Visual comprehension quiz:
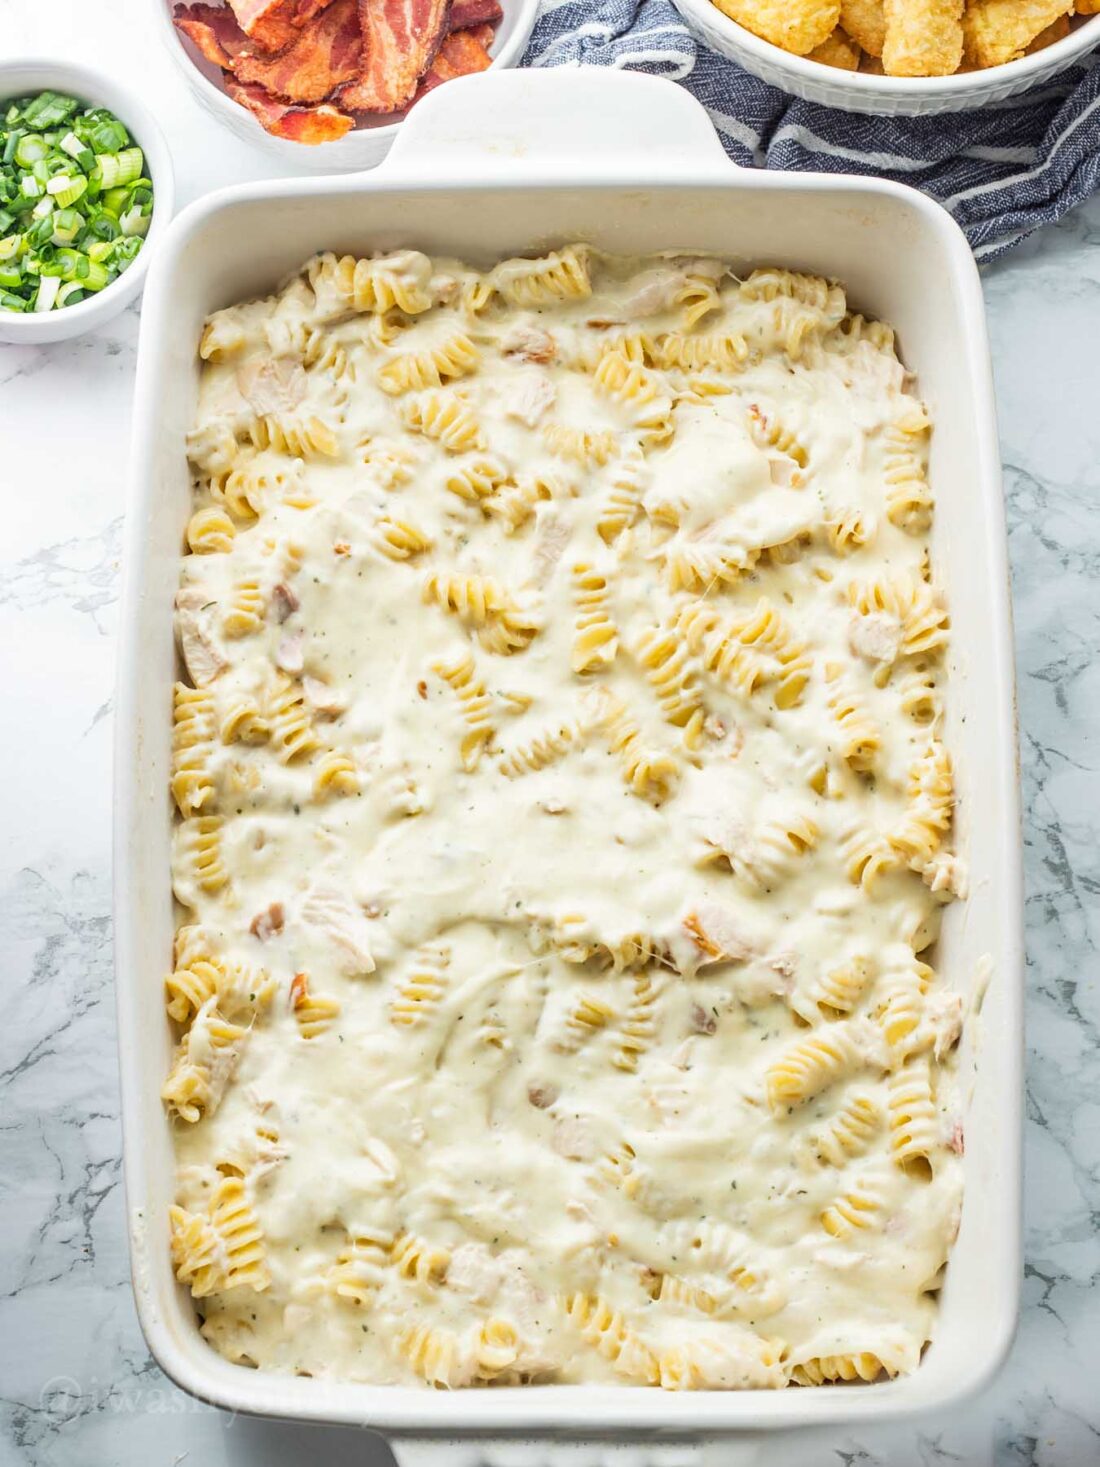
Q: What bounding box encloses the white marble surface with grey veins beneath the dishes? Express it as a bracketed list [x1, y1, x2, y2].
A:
[0, 0, 1100, 1467]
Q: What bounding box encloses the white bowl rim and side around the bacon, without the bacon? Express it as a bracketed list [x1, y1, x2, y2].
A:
[158, 0, 538, 173]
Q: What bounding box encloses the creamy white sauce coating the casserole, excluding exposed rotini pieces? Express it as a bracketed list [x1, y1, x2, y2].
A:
[165, 254, 961, 1388]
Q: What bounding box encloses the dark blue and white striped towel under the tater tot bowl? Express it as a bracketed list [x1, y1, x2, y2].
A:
[524, 0, 1100, 261]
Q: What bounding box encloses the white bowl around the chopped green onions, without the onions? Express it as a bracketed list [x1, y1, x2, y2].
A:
[0, 60, 173, 346]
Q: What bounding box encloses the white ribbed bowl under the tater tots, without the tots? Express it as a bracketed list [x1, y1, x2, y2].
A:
[672, 0, 1100, 117]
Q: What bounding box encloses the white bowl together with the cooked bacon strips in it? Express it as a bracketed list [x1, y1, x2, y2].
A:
[154, 0, 538, 173]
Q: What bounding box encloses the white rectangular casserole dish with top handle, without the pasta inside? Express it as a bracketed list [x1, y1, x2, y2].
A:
[114, 69, 1022, 1460]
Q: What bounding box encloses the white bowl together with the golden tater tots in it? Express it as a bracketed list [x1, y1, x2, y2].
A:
[673, 0, 1100, 116]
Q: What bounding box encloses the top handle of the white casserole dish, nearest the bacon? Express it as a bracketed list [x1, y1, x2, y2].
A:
[380, 66, 736, 182]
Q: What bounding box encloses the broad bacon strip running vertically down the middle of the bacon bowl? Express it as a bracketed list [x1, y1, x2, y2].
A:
[340, 0, 450, 111]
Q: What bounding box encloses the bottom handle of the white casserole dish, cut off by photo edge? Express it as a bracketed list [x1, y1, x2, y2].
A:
[387, 1432, 763, 1467]
